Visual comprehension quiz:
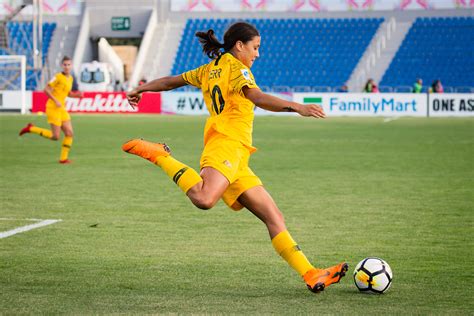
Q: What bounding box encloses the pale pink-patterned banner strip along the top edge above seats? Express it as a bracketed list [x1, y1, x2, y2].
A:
[171, 0, 474, 12]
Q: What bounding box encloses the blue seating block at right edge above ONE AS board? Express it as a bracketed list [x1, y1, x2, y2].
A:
[381, 17, 474, 92]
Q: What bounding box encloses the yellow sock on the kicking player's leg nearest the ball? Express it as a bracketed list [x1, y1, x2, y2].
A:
[272, 230, 314, 276]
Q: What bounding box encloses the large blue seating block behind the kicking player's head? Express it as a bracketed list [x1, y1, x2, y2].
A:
[172, 19, 383, 92]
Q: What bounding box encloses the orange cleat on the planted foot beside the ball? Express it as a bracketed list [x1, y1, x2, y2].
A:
[303, 262, 349, 293]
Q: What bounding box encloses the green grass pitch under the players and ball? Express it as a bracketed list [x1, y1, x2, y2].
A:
[0, 115, 474, 315]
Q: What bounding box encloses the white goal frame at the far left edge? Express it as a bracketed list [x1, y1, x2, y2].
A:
[0, 55, 27, 114]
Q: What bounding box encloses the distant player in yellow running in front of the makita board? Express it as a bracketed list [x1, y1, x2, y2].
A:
[20, 56, 82, 164]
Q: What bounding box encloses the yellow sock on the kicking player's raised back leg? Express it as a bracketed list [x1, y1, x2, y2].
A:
[156, 156, 202, 193]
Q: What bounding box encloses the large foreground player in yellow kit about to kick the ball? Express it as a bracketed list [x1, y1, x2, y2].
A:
[122, 22, 348, 293]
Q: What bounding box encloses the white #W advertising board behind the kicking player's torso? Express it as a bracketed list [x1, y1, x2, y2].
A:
[161, 92, 296, 115]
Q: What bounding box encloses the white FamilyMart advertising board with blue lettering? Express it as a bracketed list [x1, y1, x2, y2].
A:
[293, 93, 428, 117]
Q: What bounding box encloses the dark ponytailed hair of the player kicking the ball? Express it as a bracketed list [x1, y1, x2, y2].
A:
[196, 22, 260, 59]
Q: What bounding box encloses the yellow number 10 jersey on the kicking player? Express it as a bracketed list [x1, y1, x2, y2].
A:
[181, 53, 258, 152]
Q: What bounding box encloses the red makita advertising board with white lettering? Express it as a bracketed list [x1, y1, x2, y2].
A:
[32, 92, 161, 114]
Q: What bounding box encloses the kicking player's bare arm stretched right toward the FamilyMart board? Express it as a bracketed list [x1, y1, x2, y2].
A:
[242, 87, 326, 118]
